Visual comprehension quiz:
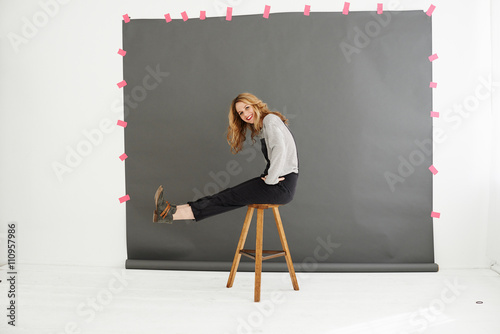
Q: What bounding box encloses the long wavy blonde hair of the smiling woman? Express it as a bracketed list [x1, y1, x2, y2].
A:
[227, 93, 288, 154]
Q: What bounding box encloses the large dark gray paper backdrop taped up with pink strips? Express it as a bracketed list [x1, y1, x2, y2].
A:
[123, 11, 437, 271]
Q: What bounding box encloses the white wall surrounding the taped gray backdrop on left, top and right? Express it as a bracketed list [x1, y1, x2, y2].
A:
[0, 0, 500, 268]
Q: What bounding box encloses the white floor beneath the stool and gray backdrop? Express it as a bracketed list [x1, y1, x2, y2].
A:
[0, 265, 500, 334]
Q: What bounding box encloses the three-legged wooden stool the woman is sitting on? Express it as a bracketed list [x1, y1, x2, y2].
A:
[227, 204, 299, 302]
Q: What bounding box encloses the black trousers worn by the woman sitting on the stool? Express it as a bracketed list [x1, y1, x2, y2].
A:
[188, 173, 299, 221]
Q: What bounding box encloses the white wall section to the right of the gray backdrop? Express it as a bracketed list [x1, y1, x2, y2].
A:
[433, 1, 492, 267]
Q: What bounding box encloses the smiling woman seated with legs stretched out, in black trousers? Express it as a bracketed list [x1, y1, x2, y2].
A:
[153, 93, 299, 224]
